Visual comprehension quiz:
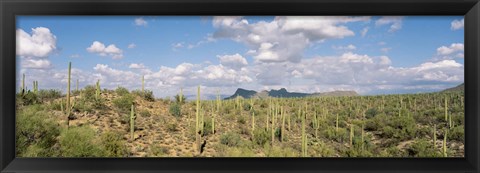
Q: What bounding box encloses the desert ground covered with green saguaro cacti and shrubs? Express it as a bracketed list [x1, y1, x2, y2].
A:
[16, 64, 465, 157]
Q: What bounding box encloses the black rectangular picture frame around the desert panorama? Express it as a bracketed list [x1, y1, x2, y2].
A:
[0, 0, 480, 173]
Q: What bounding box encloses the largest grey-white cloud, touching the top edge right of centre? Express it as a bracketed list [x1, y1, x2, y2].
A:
[212, 16, 370, 63]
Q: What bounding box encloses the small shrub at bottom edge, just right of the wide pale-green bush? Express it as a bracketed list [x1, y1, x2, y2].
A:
[101, 132, 127, 157]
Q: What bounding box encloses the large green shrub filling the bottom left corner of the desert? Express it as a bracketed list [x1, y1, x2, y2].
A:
[15, 105, 60, 157]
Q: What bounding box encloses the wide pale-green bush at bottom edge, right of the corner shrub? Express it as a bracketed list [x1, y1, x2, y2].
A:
[59, 126, 104, 157]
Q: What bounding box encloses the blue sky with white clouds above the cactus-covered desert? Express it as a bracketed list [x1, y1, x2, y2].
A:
[16, 16, 464, 97]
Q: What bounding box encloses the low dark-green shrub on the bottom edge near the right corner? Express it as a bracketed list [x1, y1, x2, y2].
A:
[406, 139, 442, 157]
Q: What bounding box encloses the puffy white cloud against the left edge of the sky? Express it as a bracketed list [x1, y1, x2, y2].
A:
[16, 27, 57, 58]
